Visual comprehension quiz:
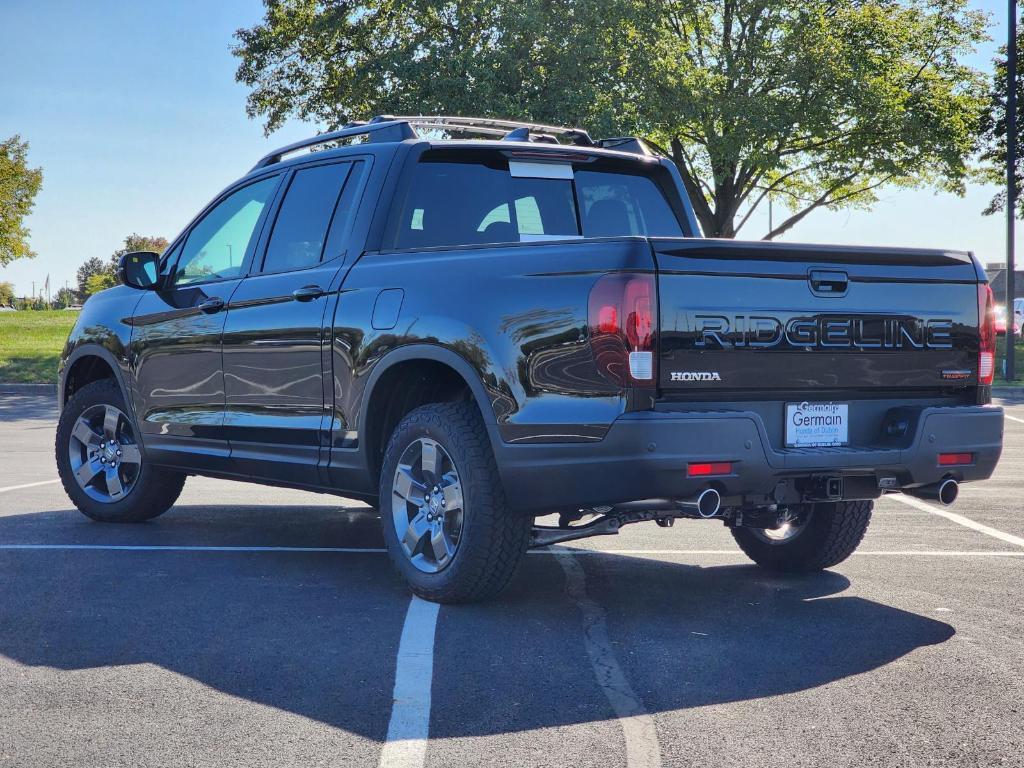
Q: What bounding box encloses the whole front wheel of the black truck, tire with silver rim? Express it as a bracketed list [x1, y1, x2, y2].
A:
[56, 379, 185, 522]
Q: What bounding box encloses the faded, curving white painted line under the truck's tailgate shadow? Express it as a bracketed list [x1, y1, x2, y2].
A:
[558, 552, 662, 768]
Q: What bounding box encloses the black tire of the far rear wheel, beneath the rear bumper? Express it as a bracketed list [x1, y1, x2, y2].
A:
[731, 501, 874, 572]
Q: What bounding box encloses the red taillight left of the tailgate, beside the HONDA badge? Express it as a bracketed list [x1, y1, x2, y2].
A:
[588, 272, 657, 387]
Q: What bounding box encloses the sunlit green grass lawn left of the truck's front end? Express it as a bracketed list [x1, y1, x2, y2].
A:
[0, 309, 78, 384]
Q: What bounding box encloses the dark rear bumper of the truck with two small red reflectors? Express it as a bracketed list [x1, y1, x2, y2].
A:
[496, 406, 1002, 513]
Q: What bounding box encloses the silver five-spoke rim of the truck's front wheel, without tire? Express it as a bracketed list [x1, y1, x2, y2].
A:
[68, 404, 142, 504]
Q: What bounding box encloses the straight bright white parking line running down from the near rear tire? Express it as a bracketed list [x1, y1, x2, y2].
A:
[378, 597, 440, 768]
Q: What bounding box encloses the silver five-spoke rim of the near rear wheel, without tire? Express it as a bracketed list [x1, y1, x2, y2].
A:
[391, 437, 465, 573]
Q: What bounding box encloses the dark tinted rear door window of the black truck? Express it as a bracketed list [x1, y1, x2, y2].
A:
[262, 163, 351, 272]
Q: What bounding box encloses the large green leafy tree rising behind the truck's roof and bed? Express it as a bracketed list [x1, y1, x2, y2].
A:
[234, 0, 985, 237]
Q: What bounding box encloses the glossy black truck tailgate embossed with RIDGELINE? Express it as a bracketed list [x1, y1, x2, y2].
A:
[651, 239, 979, 399]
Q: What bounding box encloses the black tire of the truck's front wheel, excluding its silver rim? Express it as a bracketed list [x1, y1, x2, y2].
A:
[55, 379, 185, 522]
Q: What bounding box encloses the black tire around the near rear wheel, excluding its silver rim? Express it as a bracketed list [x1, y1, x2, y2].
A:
[379, 402, 532, 603]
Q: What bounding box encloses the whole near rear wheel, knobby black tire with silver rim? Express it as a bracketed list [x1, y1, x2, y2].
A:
[380, 402, 532, 603]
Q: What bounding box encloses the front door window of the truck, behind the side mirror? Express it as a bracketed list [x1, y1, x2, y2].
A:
[174, 176, 278, 285]
